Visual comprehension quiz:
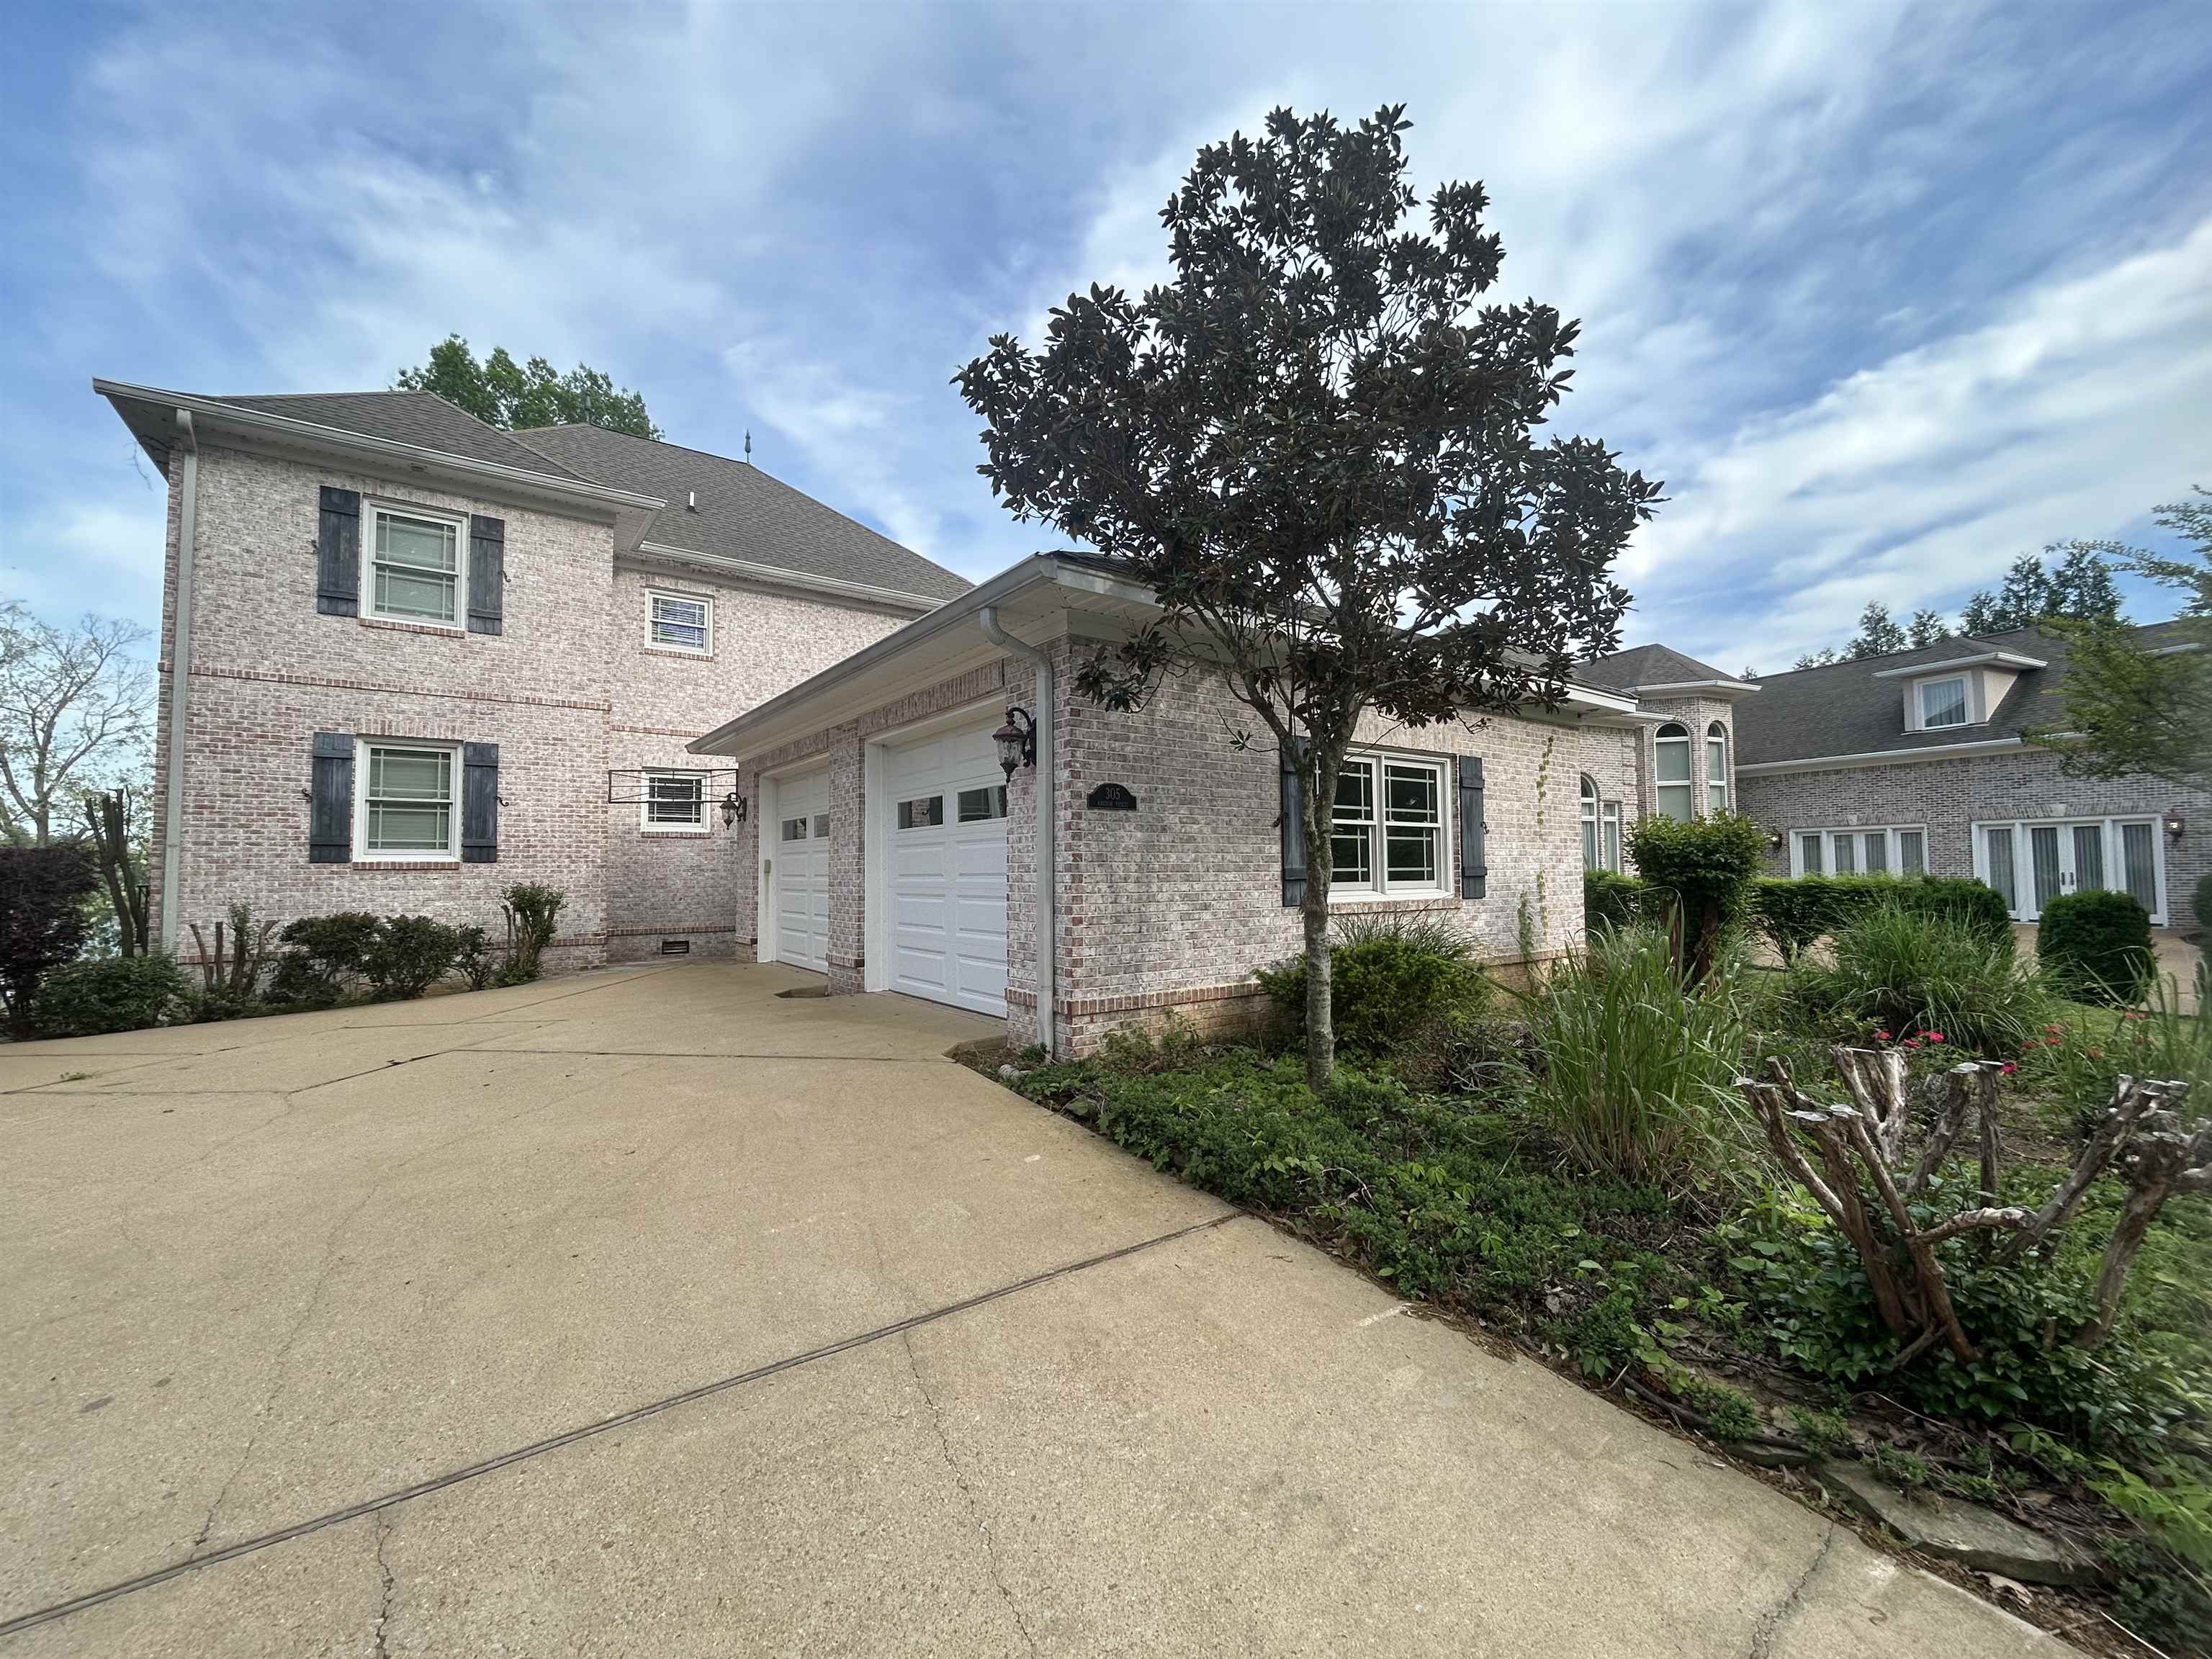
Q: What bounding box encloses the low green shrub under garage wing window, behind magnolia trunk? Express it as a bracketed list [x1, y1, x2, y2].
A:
[1259, 914, 1488, 1059]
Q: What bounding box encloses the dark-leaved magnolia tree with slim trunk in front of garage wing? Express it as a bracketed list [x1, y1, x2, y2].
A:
[958, 109, 1659, 1086]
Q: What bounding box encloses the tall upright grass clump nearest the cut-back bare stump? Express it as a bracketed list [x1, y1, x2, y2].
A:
[1515, 927, 1745, 1184]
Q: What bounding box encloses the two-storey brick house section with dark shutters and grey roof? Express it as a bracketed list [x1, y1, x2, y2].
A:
[95, 380, 969, 966]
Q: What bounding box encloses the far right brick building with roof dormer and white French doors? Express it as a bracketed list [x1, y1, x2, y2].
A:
[1737, 626, 2212, 927]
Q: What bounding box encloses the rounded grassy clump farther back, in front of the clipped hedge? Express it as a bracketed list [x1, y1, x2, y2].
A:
[1789, 904, 2051, 1057]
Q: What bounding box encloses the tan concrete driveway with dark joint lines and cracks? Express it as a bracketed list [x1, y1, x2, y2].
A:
[0, 964, 2064, 1659]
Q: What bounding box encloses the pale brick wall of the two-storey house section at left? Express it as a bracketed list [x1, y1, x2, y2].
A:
[150, 444, 904, 969]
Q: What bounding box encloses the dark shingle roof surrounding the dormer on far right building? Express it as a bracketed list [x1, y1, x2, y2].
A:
[1737, 621, 2172, 765]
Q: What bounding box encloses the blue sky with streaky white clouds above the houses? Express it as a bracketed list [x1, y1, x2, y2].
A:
[0, 0, 2212, 670]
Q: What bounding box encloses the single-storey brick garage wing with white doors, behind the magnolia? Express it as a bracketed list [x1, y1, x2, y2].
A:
[693, 553, 1750, 1053]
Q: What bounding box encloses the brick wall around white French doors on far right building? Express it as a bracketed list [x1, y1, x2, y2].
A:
[1739, 750, 2212, 927]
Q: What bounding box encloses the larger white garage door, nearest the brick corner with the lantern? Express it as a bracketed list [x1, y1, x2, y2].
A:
[876, 726, 1007, 1017]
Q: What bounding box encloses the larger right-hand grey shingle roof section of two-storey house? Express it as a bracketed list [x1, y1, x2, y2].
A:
[516, 427, 974, 600]
